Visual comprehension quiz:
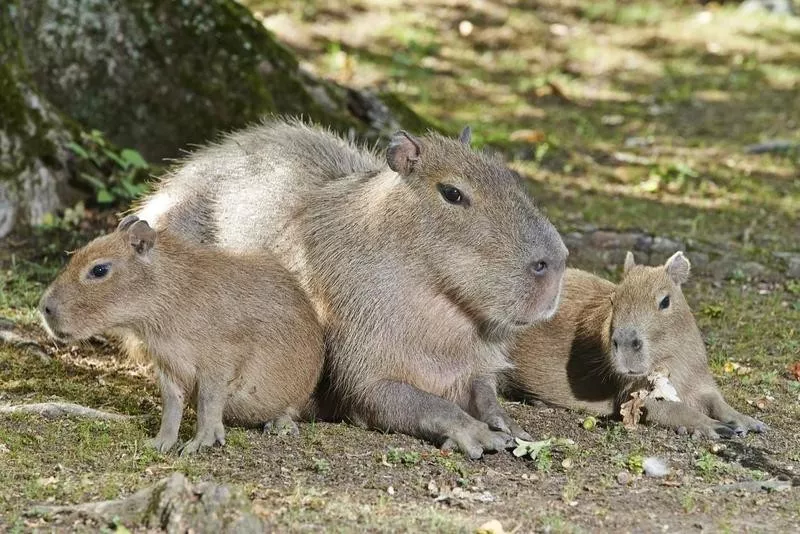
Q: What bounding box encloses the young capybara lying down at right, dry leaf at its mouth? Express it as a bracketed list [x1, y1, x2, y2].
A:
[506, 252, 766, 438]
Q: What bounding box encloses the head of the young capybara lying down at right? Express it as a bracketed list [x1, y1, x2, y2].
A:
[610, 252, 697, 378]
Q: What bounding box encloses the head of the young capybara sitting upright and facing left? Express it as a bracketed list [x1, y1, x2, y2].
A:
[39, 215, 156, 339]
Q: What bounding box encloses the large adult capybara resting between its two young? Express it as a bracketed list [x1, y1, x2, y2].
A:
[133, 120, 567, 458]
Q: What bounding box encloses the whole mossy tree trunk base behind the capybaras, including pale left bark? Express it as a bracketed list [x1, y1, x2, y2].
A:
[0, 0, 430, 236]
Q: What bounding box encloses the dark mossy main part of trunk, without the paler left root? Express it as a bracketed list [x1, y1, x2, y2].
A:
[11, 0, 434, 161]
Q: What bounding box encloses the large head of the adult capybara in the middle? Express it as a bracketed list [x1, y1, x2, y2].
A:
[387, 127, 567, 328]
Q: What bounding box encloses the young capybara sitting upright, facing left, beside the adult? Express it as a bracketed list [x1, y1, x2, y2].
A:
[39, 215, 324, 454]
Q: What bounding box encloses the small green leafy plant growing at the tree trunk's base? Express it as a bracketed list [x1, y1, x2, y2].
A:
[67, 130, 150, 204]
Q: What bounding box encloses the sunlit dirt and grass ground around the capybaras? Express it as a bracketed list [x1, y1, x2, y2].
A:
[0, 0, 800, 532]
